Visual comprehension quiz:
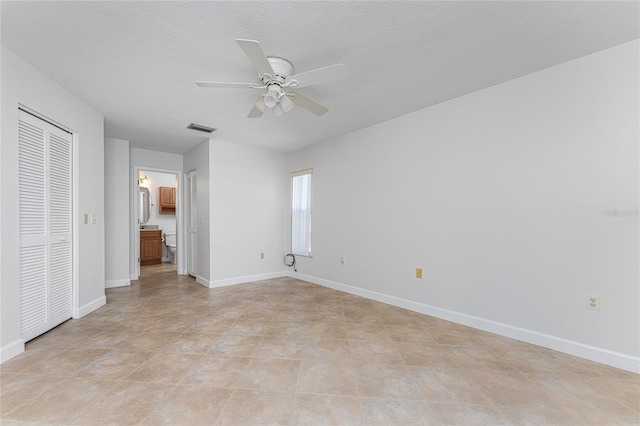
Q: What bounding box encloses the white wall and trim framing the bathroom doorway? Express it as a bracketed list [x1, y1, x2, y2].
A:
[129, 148, 184, 279]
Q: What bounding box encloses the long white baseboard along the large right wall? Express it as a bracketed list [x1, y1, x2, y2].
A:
[286, 271, 640, 374]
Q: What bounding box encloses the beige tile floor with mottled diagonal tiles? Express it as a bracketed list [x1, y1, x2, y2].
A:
[0, 265, 640, 425]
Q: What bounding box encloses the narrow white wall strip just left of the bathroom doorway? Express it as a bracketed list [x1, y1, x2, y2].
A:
[104, 138, 130, 288]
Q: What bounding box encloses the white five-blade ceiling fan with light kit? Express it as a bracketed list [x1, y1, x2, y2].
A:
[196, 39, 347, 118]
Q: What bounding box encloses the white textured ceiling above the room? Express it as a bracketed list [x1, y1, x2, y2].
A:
[1, 1, 639, 153]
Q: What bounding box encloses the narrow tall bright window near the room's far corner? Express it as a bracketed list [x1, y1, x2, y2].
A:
[291, 169, 313, 257]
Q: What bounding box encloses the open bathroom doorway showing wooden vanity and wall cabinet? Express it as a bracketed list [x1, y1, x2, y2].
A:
[132, 166, 183, 279]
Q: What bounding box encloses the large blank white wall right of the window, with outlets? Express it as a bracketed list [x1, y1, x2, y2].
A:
[288, 41, 640, 371]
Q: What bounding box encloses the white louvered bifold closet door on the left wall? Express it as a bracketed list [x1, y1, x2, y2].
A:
[18, 111, 72, 340]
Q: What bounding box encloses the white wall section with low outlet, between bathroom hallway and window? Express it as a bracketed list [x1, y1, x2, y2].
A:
[209, 140, 289, 286]
